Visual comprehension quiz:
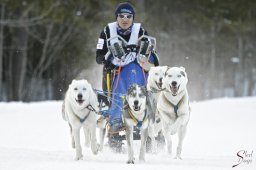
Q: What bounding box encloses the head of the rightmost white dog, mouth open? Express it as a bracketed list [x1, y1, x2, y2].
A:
[163, 67, 188, 96]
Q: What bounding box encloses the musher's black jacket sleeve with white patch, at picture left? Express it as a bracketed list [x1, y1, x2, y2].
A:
[96, 27, 108, 64]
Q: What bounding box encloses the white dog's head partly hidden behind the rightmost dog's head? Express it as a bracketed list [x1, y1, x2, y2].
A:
[147, 66, 167, 91]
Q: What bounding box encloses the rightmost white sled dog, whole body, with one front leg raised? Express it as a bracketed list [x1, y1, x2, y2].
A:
[157, 67, 190, 159]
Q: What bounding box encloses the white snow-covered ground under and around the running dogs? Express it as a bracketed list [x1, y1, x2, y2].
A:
[0, 97, 256, 170]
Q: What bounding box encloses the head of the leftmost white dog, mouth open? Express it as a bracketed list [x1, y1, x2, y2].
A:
[68, 79, 98, 110]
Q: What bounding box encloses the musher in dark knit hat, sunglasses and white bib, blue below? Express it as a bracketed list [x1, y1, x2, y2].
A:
[96, 2, 159, 149]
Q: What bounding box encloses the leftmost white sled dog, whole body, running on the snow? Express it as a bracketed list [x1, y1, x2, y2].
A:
[62, 79, 99, 160]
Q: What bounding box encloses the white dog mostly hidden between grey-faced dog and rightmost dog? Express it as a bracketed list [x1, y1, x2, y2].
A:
[147, 66, 168, 153]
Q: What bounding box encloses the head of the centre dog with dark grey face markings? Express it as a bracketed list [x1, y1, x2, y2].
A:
[124, 84, 147, 114]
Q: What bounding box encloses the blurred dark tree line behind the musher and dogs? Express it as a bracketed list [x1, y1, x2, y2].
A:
[0, 0, 256, 101]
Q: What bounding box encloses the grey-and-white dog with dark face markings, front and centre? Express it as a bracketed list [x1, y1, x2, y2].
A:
[122, 84, 149, 164]
